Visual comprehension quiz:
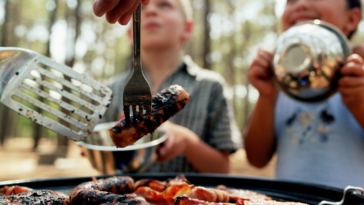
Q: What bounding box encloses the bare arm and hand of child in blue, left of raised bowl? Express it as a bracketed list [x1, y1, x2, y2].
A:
[244, 50, 278, 167]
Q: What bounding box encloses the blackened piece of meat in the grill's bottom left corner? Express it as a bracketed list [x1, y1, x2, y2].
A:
[0, 190, 71, 205]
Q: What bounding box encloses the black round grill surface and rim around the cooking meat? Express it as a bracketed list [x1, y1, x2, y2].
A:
[0, 173, 364, 205]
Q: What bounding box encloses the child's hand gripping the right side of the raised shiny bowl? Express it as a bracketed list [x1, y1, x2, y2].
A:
[337, 54, 364, 109]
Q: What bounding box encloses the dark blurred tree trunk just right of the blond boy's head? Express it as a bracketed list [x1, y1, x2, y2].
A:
[202, 0, 211, 70]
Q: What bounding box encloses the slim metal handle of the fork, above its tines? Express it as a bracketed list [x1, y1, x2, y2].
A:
[133, 4, 142, 72]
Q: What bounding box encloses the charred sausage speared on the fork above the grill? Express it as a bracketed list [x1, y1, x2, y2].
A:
[109, 85, 189, 147]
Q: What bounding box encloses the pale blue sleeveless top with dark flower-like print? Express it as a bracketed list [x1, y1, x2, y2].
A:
[274, 93, 364, 188]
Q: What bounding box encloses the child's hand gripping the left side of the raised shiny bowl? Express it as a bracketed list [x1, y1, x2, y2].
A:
[248, 49, 278, 97]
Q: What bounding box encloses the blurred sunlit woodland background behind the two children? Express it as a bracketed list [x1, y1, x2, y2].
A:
[0, 0, 364, 181]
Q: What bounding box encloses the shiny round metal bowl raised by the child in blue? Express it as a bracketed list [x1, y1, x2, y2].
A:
[273, 20, 351, 102]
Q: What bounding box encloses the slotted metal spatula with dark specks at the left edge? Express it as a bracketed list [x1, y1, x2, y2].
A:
[0, 47, 112, 141]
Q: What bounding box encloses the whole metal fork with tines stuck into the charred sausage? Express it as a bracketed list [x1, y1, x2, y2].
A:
[123, 5, 152, 122]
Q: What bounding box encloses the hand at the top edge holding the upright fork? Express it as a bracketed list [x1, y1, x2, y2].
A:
[94, 0, 150, 25]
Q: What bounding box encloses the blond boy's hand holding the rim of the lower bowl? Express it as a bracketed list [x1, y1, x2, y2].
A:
[157, 121, 199, 162]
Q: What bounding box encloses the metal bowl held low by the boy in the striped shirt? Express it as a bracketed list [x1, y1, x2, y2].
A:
[77, 122, 167, 175]
